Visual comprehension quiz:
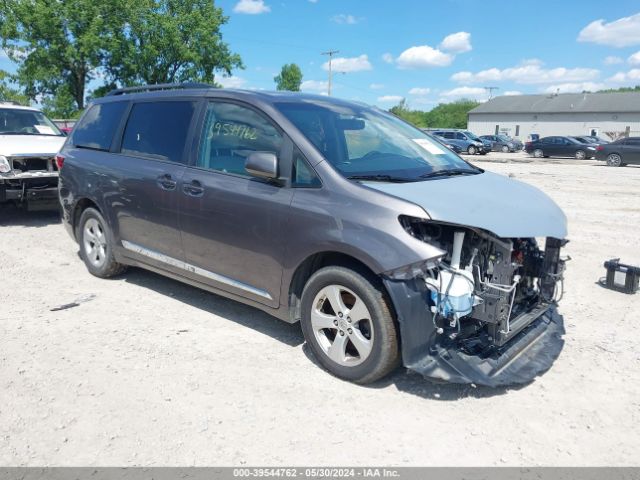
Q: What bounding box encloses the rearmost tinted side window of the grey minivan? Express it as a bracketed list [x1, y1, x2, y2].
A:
[71, 102, 128, 151]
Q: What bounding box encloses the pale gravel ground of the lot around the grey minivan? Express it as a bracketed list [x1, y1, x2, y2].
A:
[0, 154, 640, 466]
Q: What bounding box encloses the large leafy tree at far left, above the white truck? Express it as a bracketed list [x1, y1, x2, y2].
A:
[0, 0, 127, 109]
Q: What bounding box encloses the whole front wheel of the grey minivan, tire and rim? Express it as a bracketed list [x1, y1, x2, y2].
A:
[301, 267, 400, 384]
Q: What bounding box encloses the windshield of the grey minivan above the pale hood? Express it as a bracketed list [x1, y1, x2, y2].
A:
[276, 100, 482, 182]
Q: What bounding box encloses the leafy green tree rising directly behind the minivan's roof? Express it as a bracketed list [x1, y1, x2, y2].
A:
[105, 0, 243, 86]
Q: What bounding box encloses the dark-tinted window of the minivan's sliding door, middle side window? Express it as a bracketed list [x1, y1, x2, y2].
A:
[121, 101, 195, 162]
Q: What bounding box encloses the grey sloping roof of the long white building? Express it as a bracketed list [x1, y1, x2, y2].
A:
[469, 92, 640, 115]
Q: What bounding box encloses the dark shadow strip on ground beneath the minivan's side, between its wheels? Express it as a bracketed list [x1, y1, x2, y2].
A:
[121, 268, 304, 347]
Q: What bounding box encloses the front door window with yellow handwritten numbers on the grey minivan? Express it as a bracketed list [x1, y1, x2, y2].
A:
[196, 102, 282, 177]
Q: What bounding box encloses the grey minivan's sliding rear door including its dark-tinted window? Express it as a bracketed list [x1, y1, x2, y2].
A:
[111, 99, 197, 272]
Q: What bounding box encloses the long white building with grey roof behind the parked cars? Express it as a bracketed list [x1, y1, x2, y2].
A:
[468, 92, 640, 141]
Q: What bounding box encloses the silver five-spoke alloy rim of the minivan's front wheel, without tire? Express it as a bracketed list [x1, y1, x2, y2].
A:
[311, 285, 374, 367]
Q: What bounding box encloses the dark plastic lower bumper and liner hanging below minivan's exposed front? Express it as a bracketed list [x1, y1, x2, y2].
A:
[384, 279, 565, 387]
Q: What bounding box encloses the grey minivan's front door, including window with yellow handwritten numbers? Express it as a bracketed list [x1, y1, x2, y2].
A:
[178, 100, 292, 307]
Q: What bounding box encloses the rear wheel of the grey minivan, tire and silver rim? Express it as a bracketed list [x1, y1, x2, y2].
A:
[78, 207, 127, 278]
